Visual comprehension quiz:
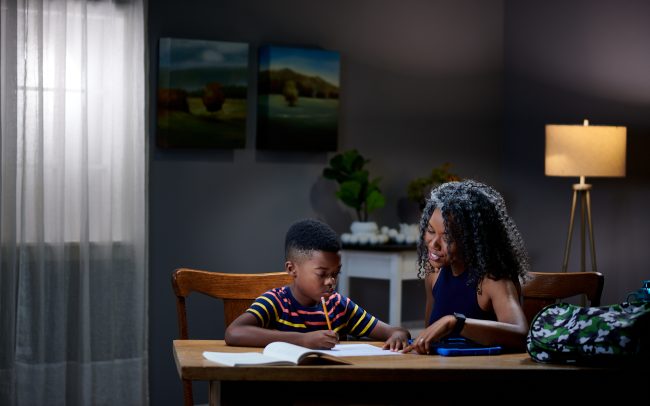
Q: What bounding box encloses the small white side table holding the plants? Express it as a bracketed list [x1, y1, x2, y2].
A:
[337, 246, 418, 326]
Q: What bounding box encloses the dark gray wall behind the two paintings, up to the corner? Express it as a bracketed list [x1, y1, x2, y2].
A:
[148, 0, 503, 405]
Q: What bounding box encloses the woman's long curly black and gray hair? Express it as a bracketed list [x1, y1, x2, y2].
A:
[417, 180, 530, 281]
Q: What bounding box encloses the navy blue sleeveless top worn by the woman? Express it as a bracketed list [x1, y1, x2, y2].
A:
[429, 267, 496, 325]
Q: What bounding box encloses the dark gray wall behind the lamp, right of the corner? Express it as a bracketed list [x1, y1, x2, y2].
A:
[503, 0, 650, 304]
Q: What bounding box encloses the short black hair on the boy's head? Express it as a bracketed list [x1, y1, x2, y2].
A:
[284, 219, 341, 259]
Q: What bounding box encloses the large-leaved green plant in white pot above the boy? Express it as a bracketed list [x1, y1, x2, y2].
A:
[323, 149, 386, 232]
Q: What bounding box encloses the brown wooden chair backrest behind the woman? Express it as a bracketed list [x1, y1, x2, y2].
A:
[521, 272, 605, 323]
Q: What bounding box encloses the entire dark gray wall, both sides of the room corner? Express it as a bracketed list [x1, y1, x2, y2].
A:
[148, 0, 650, 405]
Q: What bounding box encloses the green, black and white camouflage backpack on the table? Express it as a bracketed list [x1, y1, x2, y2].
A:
[526, 302, 650, 364]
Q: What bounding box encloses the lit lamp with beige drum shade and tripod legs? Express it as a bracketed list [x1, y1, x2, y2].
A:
[545, 120, 626, 272]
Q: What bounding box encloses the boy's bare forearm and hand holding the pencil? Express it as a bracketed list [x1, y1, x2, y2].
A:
[225, 312, 338, 349]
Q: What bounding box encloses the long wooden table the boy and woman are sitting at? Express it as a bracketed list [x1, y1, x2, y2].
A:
[173, 340, 650, 405]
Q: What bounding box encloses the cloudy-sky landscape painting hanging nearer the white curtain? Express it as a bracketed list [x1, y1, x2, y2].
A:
[156, 38, 248, 148]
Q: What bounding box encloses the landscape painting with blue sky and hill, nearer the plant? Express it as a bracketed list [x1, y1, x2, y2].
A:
[257, 46, 340, 151]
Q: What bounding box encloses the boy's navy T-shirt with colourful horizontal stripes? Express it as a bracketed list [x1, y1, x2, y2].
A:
[246, 286, 377, 337]
